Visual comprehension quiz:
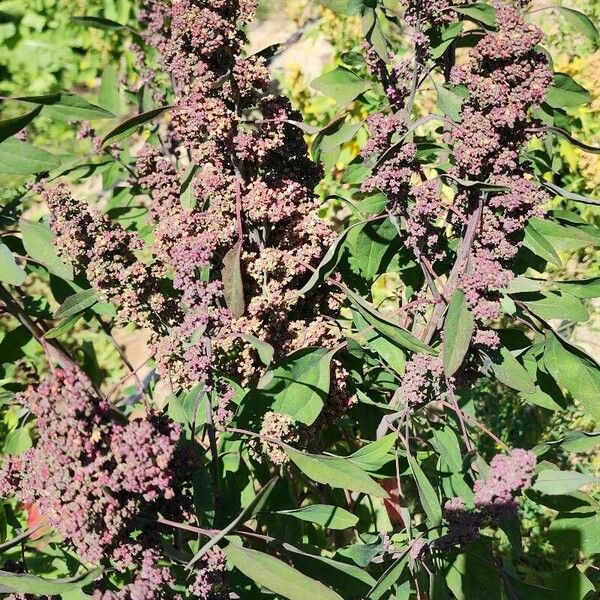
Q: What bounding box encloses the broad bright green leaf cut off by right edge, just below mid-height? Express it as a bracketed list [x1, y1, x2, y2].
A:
[544, 332, 600, 420]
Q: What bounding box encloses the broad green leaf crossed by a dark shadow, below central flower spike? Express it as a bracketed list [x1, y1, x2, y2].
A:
[259, 348, 335, 425]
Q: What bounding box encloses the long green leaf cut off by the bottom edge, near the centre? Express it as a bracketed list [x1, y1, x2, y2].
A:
[224, 544, 343, 600]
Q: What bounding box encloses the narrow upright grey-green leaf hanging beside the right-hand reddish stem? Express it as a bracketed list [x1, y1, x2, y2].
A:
[444, 290, 475, 377]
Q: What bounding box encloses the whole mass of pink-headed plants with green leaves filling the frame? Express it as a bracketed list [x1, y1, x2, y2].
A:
[0, 0, 600, 600]
